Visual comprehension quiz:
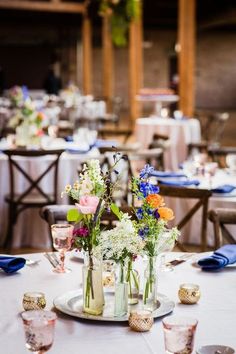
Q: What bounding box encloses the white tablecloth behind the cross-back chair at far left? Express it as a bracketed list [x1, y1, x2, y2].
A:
[0, 149, 98, 248]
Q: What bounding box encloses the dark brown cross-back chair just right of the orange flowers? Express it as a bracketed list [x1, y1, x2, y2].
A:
[159, 185, 212, 251]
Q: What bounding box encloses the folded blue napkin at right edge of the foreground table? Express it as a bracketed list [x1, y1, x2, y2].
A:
[198, 245, 236, 270]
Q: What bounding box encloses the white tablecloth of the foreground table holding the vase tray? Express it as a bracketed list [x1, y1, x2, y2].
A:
[0, 254, 236, 354]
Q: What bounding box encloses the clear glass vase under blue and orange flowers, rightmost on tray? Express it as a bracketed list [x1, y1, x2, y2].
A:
[143, 257, 157, 311]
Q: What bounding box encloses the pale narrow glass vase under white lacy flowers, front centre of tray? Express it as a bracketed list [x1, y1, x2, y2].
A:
[114, 263, 128, 317]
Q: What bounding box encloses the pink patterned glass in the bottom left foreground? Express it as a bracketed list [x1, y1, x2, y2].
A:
[21, 310, 57, 354]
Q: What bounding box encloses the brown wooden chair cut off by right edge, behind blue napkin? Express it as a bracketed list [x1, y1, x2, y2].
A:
[208, 208, 236, 249]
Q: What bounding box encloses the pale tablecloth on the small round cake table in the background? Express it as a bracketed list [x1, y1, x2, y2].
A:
[135, 118, 201, 170]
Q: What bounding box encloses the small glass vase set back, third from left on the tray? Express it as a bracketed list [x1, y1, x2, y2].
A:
[126, 259, 139, 305]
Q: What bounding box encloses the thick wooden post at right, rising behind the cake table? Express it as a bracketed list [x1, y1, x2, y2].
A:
[178, 0, 196, 117]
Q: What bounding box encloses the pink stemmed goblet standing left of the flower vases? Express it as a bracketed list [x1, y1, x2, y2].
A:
[51, 224, 74, 273]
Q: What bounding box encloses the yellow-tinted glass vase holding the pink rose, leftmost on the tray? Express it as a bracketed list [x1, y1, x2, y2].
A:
[83, 256, 104, 316]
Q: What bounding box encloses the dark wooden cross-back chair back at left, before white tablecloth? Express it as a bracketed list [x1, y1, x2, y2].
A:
[3, 149, 64, 205]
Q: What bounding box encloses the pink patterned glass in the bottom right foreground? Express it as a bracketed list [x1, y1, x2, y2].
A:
[162, 316, 198, 354]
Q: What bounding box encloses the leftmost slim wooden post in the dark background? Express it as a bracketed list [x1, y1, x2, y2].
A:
[82, 15, 92, 95]
